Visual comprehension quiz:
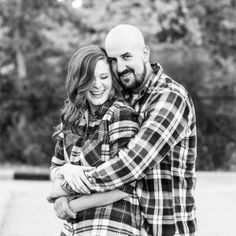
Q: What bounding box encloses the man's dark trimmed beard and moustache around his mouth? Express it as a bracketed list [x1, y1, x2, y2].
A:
[118, 64, 147, 91]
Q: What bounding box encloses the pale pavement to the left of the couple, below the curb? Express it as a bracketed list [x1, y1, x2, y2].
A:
[0, 180, 61, 236]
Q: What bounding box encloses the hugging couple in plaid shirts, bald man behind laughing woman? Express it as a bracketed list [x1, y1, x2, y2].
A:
[48, 24, 197, 236]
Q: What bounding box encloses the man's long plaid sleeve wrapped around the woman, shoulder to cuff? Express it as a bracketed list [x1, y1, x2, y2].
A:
[89, 91, 191, 192]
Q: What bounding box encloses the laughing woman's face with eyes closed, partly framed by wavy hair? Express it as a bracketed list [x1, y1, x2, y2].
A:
[86, 60, 112, 113]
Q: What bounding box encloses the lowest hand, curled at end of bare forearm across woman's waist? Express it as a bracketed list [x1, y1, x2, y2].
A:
[54, 197, 76, 220]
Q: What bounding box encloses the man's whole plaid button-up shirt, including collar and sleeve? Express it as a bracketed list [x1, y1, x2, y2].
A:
[86, 64, 196, 236]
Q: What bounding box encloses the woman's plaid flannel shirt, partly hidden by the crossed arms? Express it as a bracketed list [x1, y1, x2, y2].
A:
[51, 100, 141, 236]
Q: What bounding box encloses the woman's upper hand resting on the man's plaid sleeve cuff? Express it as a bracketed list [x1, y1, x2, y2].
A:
[60, 163, 94, 194]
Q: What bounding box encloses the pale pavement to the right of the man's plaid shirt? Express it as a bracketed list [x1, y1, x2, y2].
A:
[196, 172, 236, 236]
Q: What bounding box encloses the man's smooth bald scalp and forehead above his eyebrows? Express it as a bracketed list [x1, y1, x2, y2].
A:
[105, 24, 145, 51]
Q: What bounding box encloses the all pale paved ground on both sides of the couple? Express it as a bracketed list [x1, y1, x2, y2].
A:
[0, 172, 236, 236]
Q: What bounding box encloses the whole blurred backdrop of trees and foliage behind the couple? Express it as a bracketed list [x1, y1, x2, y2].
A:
[0, 0, 236, 171]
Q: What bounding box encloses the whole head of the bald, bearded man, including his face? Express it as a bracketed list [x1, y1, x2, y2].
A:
[102, 24, 151, 92]
